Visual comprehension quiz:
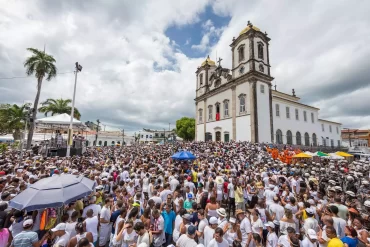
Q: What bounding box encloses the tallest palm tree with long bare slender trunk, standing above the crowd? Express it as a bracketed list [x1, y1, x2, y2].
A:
[24, 48, 57, 149]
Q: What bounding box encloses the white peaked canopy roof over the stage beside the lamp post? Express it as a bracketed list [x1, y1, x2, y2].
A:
[35, 113, 87, 129]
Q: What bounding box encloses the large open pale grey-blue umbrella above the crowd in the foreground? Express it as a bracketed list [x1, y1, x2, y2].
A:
[9, 174, 95, 211]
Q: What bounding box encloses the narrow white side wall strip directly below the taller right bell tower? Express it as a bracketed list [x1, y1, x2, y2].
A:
[256, 81, 271, 143]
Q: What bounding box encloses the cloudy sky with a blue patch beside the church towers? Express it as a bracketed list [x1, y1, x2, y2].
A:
[0, 0, 370, 132]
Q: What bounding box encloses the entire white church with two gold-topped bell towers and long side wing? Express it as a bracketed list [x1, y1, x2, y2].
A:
[195, 22, 341, 147]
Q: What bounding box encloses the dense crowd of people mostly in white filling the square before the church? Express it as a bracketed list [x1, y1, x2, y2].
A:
[0, 142, 370, 247]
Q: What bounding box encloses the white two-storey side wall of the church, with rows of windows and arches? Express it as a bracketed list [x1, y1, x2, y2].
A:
[272, 99, 320, 145]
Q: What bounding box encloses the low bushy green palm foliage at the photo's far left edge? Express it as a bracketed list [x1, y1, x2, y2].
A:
[0, 104, 30, 140]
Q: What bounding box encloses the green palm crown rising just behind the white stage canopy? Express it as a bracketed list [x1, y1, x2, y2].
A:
[39, 99, 81, 120]
